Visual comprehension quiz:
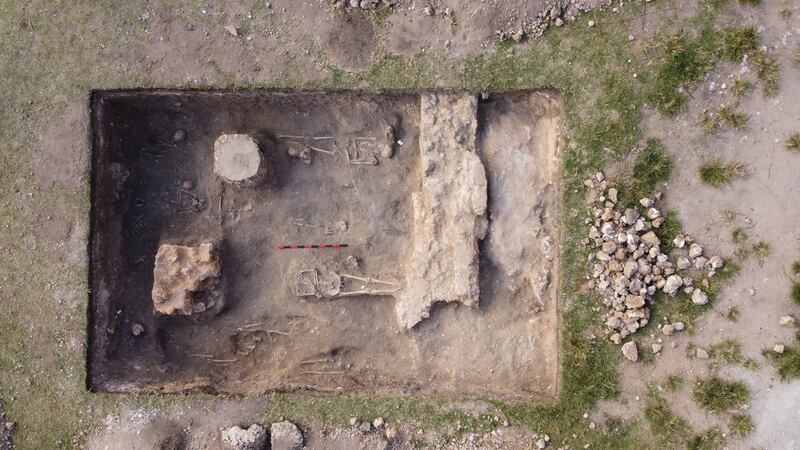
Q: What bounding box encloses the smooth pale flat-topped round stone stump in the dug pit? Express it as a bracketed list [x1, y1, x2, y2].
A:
[214, 134, 267, 185]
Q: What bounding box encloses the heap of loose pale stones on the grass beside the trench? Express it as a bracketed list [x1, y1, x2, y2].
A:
[584, 173, 723, 344]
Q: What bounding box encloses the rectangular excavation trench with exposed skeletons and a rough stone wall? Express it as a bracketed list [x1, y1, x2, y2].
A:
[87, 91, 561, 400]
